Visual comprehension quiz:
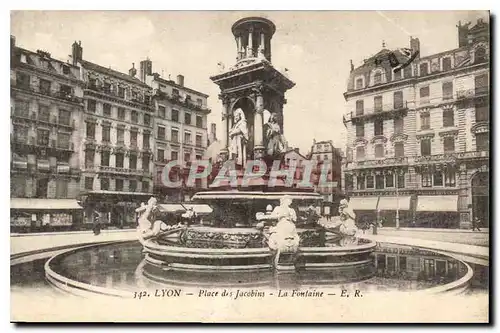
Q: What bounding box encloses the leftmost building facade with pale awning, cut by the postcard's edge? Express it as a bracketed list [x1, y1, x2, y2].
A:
[10, 36, 83, 231]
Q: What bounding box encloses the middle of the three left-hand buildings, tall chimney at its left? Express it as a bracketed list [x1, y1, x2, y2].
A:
[72, 42, 154, 227]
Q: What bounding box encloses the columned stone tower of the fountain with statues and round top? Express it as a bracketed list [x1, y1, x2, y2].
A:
[211, 17, 295, 166]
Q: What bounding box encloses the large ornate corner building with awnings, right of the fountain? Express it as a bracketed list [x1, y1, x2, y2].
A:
[343, 20, 490, 228]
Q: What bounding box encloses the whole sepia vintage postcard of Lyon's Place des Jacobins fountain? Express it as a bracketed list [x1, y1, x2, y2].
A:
[9, 11, 491, 323]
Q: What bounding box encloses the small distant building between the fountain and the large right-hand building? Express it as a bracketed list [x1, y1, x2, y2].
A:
[310, 140, 342, 215]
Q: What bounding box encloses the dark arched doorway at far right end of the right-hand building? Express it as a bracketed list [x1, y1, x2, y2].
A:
[471, 172, 490, 228]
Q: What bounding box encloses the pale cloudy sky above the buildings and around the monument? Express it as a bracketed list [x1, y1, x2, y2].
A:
[11, 11, 487, 154]
